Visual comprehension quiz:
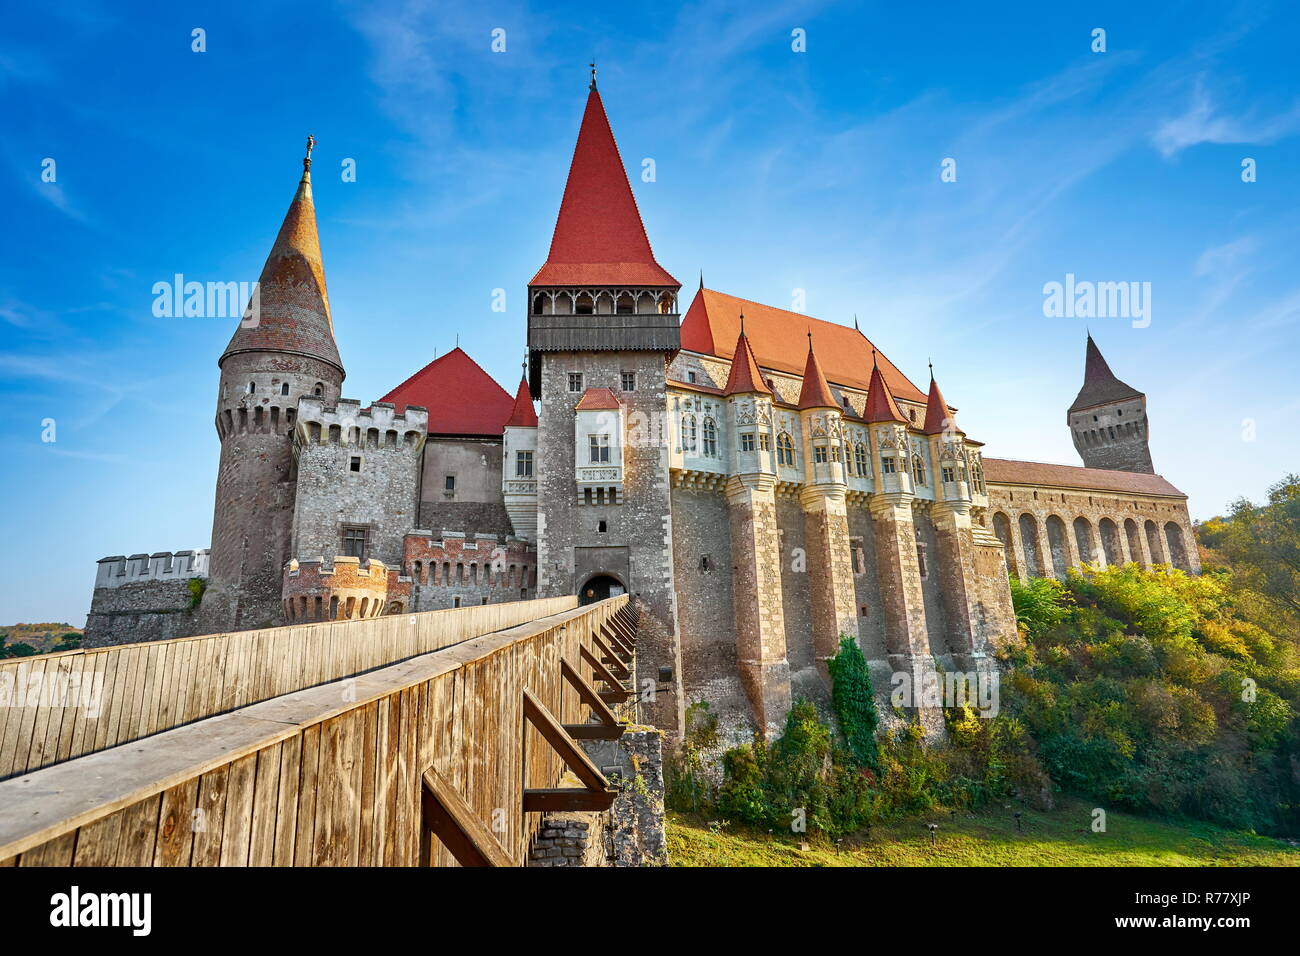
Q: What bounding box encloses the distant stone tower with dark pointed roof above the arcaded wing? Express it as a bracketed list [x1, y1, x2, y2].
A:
[1066, 334, 1156, 475]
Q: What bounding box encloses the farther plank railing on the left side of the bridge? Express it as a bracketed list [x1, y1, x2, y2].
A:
[0, 596, 577, 780]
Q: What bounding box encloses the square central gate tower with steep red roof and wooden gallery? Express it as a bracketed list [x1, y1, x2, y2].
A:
[528, 70, 684, 730]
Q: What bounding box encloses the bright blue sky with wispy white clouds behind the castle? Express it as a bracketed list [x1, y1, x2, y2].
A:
[0, 0, 1300, 626]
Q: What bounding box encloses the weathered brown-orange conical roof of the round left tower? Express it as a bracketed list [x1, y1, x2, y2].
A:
[217, 137, 343, 372]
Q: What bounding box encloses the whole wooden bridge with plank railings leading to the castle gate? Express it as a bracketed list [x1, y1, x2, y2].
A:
[0, 596, 638, 866]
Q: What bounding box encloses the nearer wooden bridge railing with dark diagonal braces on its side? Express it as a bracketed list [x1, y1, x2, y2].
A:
[0, 596, 637, 866]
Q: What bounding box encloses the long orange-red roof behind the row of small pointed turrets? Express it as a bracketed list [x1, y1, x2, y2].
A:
[681, 289, 926, 402]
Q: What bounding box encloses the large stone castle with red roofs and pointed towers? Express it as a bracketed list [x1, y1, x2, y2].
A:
[86, 75, 1199, 732]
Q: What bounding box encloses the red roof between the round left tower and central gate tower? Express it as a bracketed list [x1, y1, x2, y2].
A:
[380, 347, 515, 436]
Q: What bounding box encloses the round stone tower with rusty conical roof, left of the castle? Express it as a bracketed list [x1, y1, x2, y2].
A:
[198, 138, 345, 633]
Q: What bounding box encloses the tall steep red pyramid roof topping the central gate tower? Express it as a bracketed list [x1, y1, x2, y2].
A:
[529, 87, 680, 286]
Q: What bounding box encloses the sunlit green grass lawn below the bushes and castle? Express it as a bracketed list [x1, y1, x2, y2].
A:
[668, 799, 1300, 866]
